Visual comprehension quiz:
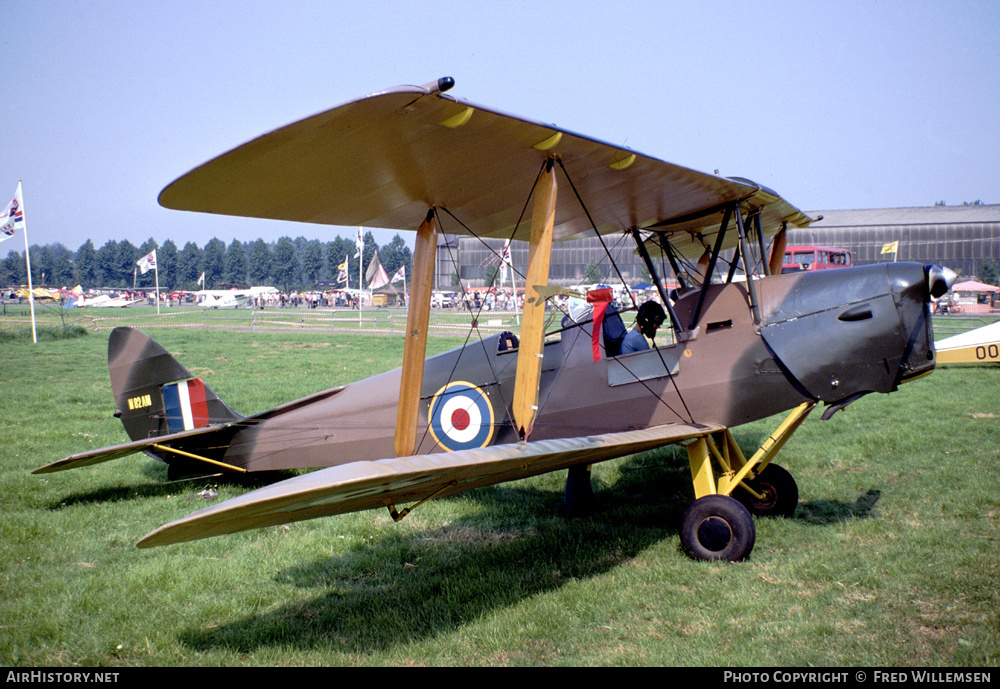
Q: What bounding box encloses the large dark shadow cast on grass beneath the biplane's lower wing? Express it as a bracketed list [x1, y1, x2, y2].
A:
[180, 448, 878, 653]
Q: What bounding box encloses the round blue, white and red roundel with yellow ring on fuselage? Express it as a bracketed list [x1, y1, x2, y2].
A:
[430, 381, 493, 451]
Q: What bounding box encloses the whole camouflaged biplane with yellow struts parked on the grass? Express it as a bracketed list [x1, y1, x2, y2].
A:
[36, 78, 953, 561]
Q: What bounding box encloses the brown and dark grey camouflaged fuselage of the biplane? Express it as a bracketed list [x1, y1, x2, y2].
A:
[97, 263, 934, 471]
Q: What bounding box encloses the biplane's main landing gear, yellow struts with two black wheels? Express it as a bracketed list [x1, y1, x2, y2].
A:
[681, 402, 816, 562]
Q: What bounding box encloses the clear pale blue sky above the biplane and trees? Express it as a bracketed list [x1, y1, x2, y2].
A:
[0, 0, 1000, 256]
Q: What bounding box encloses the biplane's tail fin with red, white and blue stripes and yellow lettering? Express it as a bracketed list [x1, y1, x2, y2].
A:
[108, 328, 244, 440]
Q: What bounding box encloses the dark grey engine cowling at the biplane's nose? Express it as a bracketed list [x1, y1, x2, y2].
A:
[758, 263, 953, 404]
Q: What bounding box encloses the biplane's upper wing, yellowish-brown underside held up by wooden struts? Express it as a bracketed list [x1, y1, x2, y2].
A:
[159, 80, 808, 245]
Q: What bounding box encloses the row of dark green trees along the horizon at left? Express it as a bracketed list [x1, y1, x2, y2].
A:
[0, 231, 413, 292]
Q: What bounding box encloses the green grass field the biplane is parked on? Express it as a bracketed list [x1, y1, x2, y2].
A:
[0, 314, 1000, 666]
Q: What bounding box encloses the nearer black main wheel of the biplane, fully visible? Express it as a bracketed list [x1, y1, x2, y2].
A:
[681, 495, 757, 562]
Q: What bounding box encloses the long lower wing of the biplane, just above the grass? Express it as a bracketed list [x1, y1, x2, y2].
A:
[139, 424, 723, 548]
